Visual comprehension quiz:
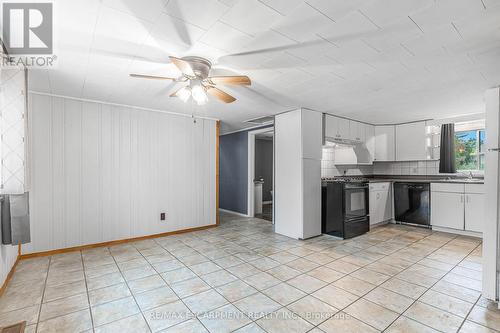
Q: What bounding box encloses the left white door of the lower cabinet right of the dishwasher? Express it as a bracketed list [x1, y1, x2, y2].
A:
[431, 192, 465, 230]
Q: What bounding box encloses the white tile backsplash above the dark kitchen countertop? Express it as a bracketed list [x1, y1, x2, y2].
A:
[321, 148, 439, 177]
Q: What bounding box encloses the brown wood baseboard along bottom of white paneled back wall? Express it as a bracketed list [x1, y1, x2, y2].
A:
[18, 224, 217, 260]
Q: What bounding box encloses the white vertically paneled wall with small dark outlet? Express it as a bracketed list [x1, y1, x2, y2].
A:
[23, 94, 216, 253]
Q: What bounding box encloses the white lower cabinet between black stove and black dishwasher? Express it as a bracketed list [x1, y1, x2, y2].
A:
[369, 182, 392, 225]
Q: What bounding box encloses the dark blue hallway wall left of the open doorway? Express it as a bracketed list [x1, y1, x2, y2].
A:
[219, 126, 272, 214]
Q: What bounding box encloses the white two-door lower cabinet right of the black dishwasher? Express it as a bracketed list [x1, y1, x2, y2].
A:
[431, 183, 485, 233]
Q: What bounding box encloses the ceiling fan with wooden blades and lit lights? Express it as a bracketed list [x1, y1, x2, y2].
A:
[130, 57, 252, 105]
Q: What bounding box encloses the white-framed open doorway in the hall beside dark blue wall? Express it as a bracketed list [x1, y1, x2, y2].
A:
[248, 128, 274, 222]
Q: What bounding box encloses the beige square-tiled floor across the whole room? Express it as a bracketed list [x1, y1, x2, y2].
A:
[0, 211, 500, 333]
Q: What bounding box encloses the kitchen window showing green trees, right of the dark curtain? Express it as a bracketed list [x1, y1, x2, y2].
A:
[455, 130, 486, 171]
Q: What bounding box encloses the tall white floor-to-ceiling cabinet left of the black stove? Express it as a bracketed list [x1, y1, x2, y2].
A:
[274, 109, 323, 239]
